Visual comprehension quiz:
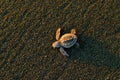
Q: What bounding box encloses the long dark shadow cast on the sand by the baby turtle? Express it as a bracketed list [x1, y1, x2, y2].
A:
[67, 36, 120, 68]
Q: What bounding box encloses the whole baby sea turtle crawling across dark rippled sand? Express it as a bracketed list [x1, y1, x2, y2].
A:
[52, 28, 79, 57]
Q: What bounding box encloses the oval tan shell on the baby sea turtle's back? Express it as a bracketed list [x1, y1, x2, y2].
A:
[59, 33, 77, 48]
